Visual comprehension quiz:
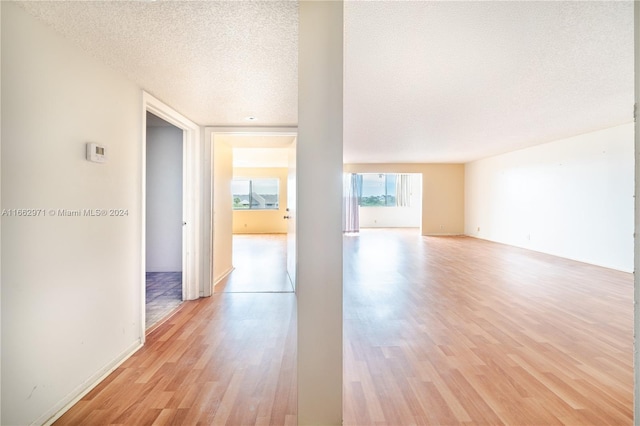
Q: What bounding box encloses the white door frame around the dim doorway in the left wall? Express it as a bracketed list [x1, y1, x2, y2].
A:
[140, 91, 201, 343]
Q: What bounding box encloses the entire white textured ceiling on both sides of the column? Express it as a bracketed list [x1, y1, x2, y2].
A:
[15, 1, 634, 163]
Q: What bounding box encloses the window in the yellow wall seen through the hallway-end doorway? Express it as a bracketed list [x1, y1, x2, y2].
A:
[231, 178, 280, 210]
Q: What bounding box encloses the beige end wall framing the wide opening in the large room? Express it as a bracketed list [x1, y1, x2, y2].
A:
[344, 164, 464, 235]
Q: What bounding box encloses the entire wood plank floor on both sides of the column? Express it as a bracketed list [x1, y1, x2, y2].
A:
[56, 230, 633, 425]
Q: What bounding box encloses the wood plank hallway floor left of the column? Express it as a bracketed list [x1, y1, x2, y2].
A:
[55, 293, 296, 426]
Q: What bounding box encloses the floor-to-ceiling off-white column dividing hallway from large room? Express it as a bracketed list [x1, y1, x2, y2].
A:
[296, 1, 343, 425]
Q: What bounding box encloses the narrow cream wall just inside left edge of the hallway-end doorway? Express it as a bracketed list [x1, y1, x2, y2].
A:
[212, 136, 233, 285]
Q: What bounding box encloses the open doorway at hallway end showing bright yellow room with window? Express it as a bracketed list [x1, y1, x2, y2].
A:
[212, 131, 296, 293]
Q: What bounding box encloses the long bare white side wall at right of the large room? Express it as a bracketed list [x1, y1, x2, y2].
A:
[465, 123, 634, 272]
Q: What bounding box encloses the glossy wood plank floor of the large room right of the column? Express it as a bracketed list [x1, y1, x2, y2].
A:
[344, 230, 633, 425]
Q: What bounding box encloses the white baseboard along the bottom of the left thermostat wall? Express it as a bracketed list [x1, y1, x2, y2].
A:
[41, 340, 143, 426]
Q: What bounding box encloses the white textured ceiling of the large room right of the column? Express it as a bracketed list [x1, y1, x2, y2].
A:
[344, 1, 634, 162]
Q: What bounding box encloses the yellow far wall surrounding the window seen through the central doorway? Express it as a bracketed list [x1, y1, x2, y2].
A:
[233, 167, 289, 234]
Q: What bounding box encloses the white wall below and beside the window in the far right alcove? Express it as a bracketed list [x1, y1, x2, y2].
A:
[360, 173, 422, 228]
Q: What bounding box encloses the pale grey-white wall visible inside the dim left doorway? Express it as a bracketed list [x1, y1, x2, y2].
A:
[146, 126, 183, 272]
